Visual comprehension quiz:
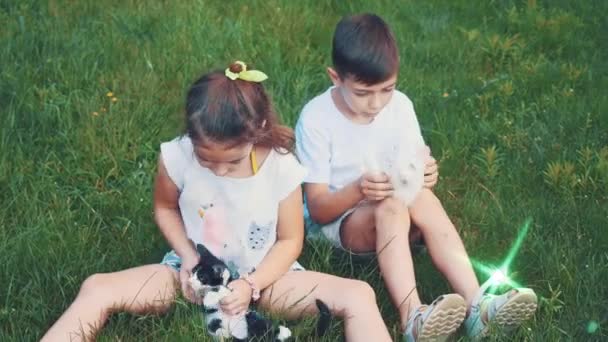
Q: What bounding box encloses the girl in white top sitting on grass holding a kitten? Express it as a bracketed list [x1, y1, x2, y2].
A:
[42, 62, 390, 341]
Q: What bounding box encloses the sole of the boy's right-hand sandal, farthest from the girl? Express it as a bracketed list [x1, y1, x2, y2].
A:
[493, 291, 538, 331]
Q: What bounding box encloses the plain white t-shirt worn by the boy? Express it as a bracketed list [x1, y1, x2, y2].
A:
[295, 87, 424, 192]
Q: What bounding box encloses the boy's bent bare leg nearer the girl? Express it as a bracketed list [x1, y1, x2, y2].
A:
[340, 198, 420, 327]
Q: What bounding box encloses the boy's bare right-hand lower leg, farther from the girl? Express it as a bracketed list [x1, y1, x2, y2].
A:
[410, 189, 479, 307]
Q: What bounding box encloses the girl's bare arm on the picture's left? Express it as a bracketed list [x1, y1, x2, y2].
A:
[154, 157, 198, 260]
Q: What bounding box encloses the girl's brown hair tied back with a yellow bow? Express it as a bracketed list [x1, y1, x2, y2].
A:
[186, 63, 294, 152]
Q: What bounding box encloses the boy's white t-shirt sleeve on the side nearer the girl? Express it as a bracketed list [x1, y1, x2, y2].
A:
[295, 117, 331, 184]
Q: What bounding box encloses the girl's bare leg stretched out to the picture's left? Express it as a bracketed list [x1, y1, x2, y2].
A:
[42, 264, 179, 342]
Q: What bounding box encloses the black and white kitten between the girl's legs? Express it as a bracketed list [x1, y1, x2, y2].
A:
[190, 244, 331, 342]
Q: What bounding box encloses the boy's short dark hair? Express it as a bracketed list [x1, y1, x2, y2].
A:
[331, 13, 399, 84]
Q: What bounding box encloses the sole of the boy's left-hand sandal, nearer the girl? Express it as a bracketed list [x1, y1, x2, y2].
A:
[416, 294, 467, 342]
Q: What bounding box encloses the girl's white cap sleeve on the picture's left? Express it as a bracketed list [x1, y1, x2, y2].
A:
[160, 137, 192, 191]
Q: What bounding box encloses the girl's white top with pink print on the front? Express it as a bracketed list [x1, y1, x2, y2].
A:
[161, 136, 306, 274]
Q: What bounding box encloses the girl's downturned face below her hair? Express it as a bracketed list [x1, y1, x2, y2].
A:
[194, 141, 253, 178]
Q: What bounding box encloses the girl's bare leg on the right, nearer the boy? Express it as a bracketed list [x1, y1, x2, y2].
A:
[260, 271, 391, 342]
